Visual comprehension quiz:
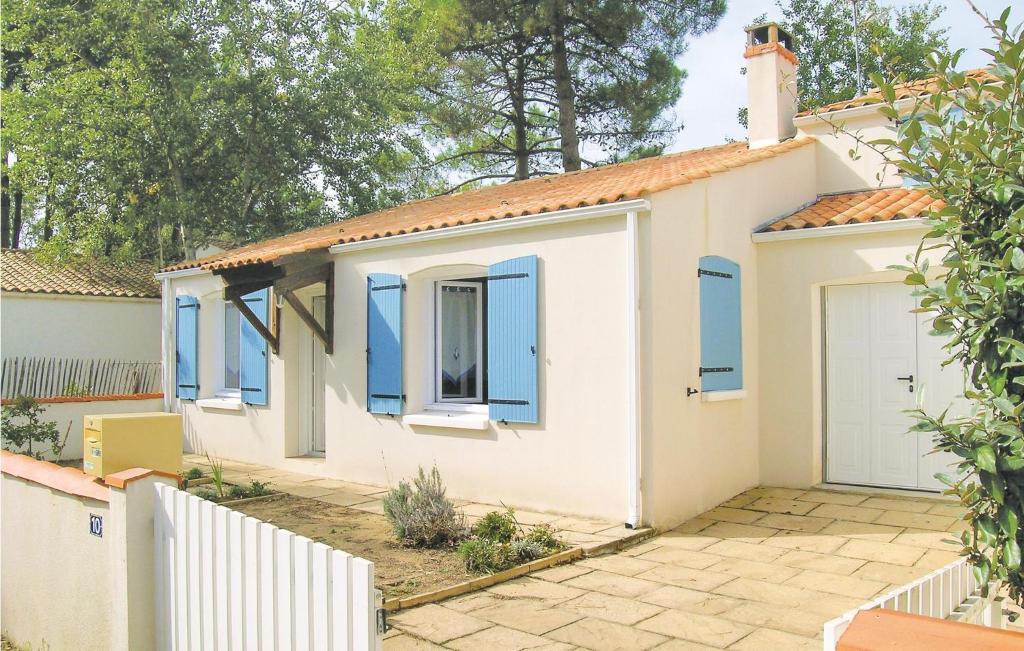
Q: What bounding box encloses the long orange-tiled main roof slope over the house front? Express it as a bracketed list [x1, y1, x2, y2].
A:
[166, 138, 813, 271]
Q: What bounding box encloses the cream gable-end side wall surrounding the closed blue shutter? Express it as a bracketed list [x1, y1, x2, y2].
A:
[641, 140, 815, 527]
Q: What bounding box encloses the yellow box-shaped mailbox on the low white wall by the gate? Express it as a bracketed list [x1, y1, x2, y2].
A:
[82, 411, 181, 478]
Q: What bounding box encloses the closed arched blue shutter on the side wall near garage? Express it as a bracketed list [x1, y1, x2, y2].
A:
[697, 256, 743, 391]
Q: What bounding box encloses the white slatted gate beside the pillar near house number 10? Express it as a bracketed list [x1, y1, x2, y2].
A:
[154, 485, 383, 650]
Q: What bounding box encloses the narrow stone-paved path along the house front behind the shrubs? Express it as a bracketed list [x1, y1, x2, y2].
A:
[184, 454, 643, 552]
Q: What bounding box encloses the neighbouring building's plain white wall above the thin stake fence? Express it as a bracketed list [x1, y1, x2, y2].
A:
[0, 292, 160, 361]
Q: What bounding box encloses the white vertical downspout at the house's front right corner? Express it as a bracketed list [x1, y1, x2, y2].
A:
[626, 210, 642, 529]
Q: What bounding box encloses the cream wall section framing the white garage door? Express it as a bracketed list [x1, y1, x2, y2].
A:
[757, 224, 938, 487]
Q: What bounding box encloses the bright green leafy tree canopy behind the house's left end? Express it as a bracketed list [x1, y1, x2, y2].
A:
[2, 0, 431, 262]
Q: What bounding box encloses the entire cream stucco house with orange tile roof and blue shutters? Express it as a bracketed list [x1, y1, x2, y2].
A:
[159, 26, 978, 527]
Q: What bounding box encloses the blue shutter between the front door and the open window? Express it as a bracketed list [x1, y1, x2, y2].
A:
[367, 273, 404, 416]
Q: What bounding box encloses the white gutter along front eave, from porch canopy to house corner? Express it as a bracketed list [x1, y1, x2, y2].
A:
[329, 199, 650, 253]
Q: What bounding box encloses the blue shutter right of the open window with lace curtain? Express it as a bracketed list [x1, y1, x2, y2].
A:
[487, 256, 539, 423]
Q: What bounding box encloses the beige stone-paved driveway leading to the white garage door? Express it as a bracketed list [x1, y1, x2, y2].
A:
[384, 488, 959, 651]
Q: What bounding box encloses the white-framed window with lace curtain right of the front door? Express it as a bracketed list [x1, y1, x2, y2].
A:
[434, 278, 487, 404]
